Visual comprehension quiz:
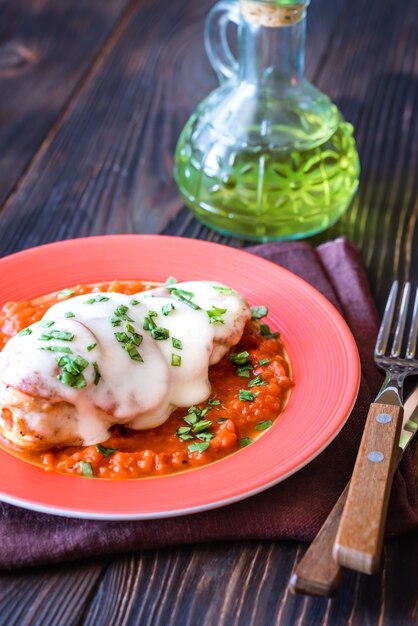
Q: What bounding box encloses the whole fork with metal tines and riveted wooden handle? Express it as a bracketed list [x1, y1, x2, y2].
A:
[333, 281, 418, 574]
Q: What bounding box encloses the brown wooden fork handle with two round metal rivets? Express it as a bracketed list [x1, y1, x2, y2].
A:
[333, 402, 403, 574]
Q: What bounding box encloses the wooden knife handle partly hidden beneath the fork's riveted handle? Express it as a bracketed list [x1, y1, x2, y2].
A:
[290, 484, 348, 596]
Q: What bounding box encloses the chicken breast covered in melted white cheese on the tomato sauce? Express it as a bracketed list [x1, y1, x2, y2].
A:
[0, 281, 251, 445]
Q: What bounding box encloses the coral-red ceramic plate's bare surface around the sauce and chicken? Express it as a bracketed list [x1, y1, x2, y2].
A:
[0, 235, 360, 519]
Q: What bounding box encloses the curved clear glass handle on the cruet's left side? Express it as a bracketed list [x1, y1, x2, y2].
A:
[205, 0, 240, 83]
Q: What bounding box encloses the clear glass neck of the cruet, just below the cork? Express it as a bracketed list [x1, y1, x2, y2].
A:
[239, 14, 306, 89]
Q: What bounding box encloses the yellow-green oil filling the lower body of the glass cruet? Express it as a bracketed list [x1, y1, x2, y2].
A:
[175, 118, 359, 241]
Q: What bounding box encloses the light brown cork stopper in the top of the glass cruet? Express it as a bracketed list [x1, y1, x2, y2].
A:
[240, 0, 306, 28]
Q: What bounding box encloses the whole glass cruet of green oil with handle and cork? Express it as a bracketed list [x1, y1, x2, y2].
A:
[174, 0, 359, 241]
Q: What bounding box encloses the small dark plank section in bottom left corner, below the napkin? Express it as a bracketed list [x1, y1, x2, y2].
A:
[0, 559, 108, 626]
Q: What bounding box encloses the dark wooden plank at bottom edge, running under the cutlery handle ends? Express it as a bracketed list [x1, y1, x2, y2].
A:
[78, 533, 418, 626]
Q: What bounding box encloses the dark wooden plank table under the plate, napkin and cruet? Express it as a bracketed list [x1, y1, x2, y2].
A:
[0, 0, 418, 626]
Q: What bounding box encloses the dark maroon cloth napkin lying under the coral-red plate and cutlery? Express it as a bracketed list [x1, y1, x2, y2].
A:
[0, 239, 418, 569]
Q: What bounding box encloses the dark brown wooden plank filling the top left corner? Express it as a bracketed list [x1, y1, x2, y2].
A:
[0, 0, 131, 205]
